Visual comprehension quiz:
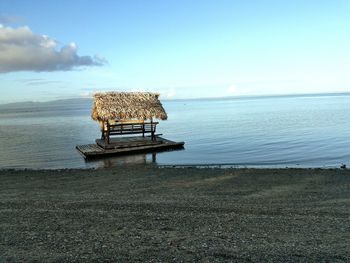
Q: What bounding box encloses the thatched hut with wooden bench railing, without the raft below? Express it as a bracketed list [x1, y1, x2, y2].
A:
[91, 92, 167, 144]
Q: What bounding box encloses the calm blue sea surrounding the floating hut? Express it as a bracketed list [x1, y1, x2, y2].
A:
[0, 94, 350, 169]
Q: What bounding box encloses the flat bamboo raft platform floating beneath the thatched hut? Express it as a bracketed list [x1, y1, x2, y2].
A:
[76, 136, 185, 159]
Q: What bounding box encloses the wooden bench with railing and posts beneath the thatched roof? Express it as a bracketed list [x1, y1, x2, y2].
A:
[101, 122, 158, 144]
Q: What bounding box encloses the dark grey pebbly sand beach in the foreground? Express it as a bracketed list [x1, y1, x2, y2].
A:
[0, 166, 350, 262]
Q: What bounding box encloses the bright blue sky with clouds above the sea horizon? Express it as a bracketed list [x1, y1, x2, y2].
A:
[0, 0, 350, 103]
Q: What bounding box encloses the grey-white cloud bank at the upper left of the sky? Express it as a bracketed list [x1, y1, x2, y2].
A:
[0, 25, 106, 73]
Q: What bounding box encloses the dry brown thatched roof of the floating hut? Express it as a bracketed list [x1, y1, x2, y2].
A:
[91, 92, 168, 121]
